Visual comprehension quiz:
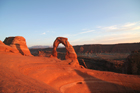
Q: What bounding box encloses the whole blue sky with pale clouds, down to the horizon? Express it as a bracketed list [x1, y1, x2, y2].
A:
[0, 0, 140, 47]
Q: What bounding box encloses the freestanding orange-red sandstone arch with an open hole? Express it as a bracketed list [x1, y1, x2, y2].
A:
[51, 37, 79, 65]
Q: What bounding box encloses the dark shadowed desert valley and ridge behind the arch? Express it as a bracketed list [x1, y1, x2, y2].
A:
[30, 43, 140, 74]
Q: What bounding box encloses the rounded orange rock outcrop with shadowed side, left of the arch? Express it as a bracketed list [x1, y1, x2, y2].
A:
[3, 36, 31, 56]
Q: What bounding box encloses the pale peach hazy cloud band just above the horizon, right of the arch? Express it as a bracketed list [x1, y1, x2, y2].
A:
[67, 32, 140, 45]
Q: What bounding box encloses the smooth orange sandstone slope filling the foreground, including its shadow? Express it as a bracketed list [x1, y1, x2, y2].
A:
[0, 51, 140, 93]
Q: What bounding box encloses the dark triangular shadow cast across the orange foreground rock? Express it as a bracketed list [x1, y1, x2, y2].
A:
[75, 70, 140, 93]
